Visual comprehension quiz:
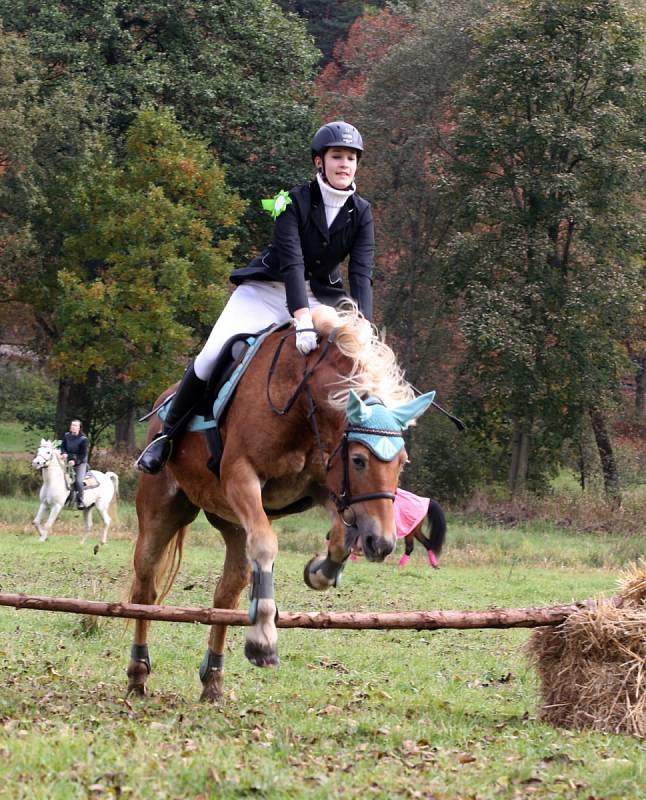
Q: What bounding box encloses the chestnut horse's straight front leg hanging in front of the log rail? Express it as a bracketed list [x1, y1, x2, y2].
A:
[222, 458, 278, 667]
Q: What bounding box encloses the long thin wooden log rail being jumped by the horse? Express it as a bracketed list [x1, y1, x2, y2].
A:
[0, 593, 622, 631]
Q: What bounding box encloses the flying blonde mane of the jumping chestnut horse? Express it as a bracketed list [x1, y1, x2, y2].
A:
[312, 302, 415, 410]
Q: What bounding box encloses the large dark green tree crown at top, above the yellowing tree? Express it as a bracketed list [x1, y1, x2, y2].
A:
[0, 0, 318, 249]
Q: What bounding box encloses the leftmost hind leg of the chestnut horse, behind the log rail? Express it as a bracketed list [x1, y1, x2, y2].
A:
[128, 478, 199, 695]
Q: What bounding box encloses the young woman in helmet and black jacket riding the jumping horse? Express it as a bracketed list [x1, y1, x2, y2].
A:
[136, 120, 374, 473]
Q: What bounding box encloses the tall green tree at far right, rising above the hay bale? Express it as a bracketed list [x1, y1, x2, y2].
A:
[447, 0, 644, 497]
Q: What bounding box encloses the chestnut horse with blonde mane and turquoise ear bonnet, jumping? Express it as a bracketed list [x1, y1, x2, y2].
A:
[128, 307, 435, 702]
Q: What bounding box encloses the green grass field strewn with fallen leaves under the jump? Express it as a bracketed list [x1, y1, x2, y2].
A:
[0, 498, 646, 800]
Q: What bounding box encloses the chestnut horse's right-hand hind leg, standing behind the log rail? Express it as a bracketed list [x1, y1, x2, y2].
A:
[200, 514, 250, 703]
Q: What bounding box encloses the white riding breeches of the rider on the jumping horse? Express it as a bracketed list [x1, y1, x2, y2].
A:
[193, 281, 322, 381]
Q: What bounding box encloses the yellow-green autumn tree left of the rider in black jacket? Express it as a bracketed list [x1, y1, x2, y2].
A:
[56, 110, 245, 446]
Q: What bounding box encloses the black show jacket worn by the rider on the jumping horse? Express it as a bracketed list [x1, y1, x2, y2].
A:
[231, 180, 375, 319]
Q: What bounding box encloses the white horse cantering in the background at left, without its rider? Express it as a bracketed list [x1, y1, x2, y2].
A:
[31, 439, 119, 544]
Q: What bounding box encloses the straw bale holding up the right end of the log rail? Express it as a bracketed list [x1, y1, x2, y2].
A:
[527, 565, 646, 736]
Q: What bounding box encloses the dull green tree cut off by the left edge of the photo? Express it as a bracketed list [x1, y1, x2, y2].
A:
[0, 29, 100, 349]
